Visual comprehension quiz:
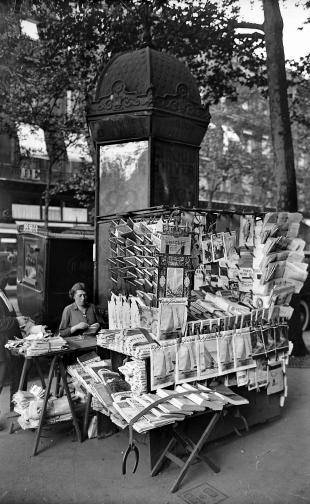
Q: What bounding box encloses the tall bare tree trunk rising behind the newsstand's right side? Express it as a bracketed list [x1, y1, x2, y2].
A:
[263, 0, 298, 212]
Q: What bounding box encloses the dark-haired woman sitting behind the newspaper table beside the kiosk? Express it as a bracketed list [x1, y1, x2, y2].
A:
[59, 282, 100, 337]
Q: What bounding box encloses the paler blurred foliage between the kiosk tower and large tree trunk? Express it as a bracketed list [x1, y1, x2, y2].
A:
[200, 87, 275, 208]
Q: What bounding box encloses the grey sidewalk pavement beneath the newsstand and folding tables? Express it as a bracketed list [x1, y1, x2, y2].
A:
[0, 368, 310, 504]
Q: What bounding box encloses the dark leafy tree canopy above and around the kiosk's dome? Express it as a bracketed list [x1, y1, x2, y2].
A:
[0, 0, 309, 212]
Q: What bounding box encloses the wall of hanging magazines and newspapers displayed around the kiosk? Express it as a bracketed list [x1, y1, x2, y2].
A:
[98, 207, 307, 396]
